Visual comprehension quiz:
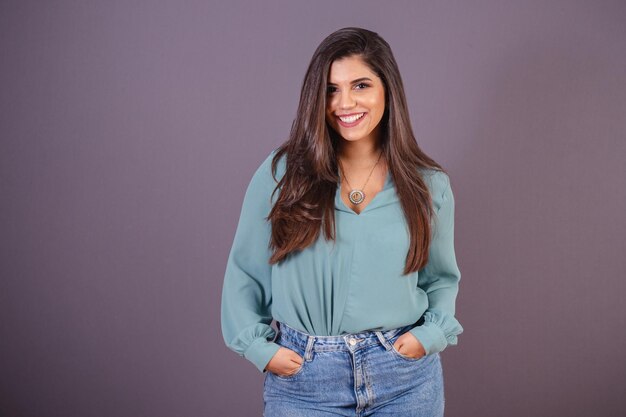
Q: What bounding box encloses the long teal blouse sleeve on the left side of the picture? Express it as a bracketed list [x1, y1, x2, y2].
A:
[221, 152, 280, 372]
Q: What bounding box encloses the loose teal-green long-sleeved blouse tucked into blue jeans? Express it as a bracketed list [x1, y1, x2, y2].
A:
[221, 150, 463, 372]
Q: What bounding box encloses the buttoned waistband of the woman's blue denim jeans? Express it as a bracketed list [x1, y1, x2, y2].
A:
[276, 322, 414, 360]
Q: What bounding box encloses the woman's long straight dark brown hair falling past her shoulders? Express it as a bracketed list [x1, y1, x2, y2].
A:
[267, 27, 445, 275]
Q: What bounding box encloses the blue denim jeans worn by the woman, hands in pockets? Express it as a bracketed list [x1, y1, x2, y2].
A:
[263, 322, 444, 417]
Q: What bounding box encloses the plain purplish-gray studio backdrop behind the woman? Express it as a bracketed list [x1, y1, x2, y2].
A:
[0, 0, 626, 417]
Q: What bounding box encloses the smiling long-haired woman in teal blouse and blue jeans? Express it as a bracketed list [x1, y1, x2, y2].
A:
[221, 27, 463, 417]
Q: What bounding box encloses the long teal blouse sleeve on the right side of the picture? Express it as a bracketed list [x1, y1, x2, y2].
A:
[410, 173, 463, 354]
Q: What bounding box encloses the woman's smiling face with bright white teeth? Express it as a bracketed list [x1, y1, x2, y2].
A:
[326, 56, 385, 143]
